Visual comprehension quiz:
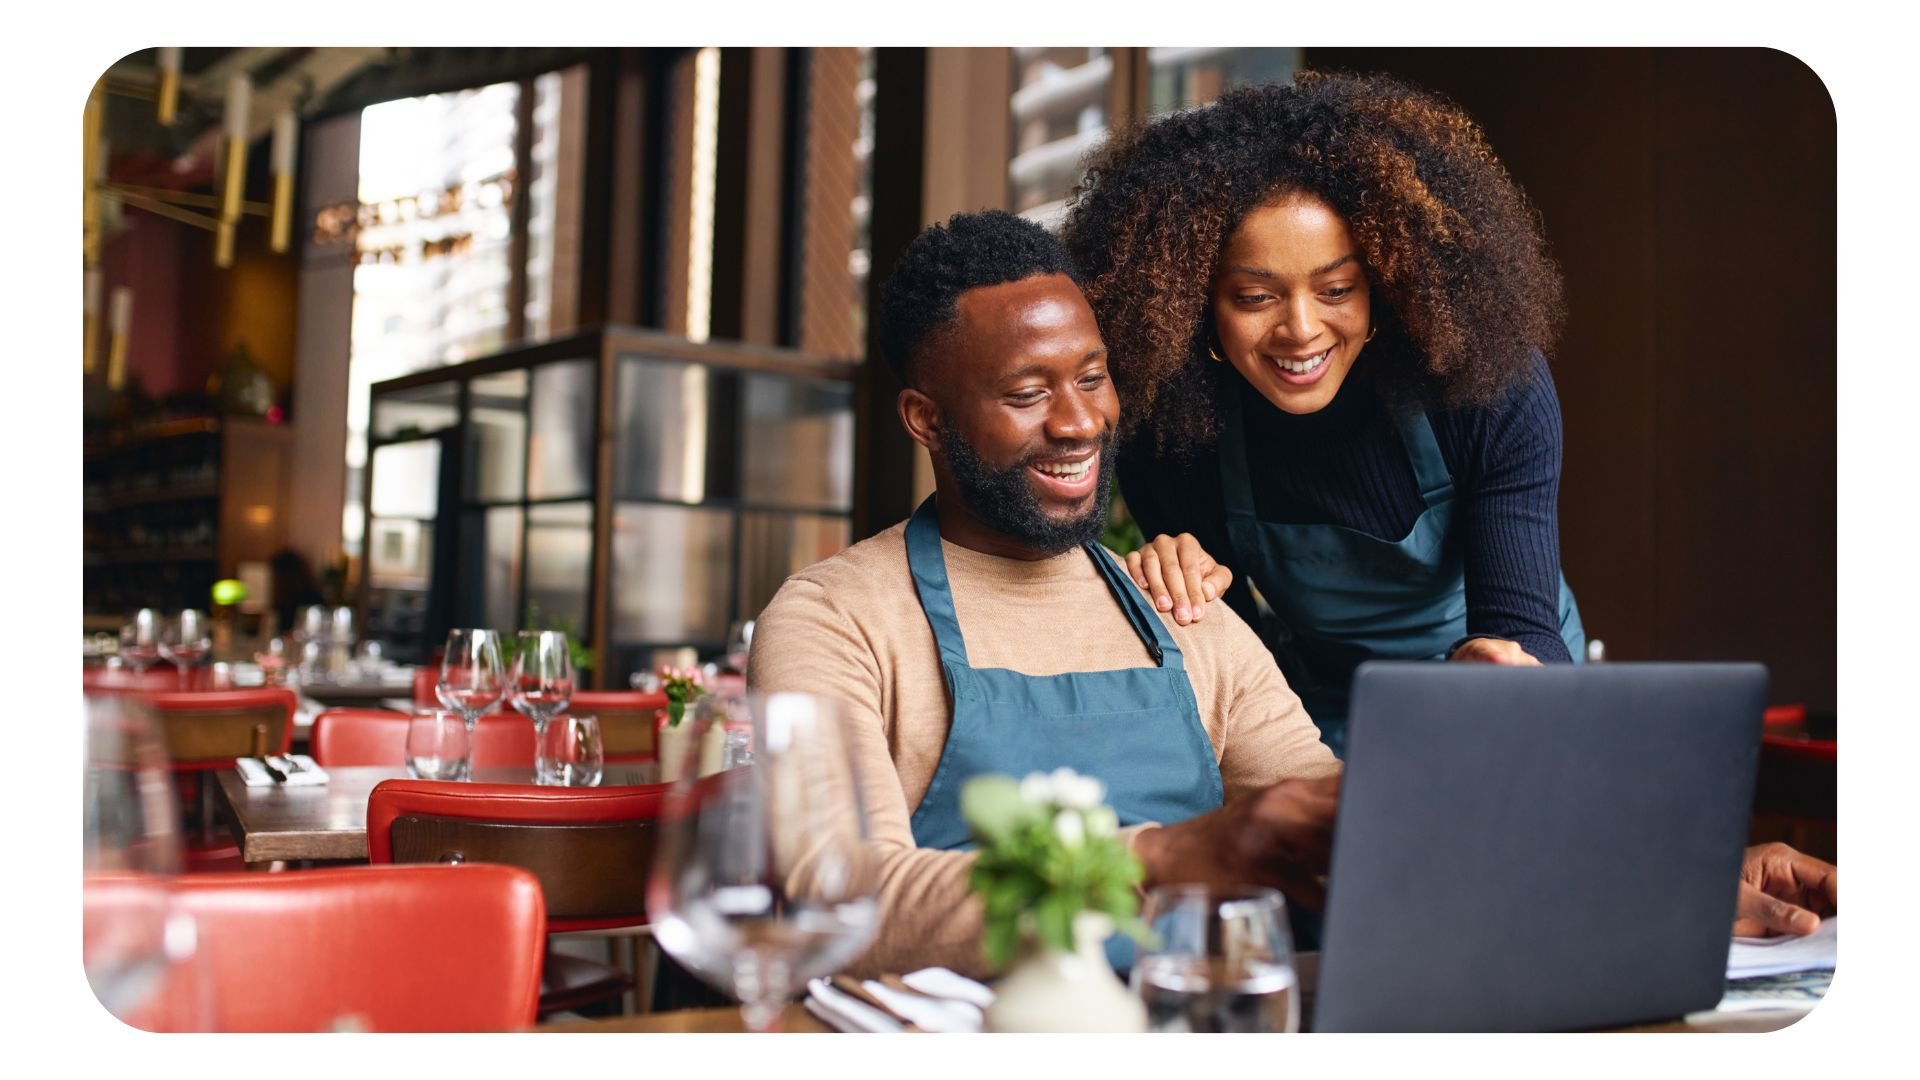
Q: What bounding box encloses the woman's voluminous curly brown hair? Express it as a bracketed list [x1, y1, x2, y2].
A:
[1064, 71, 1561, 454]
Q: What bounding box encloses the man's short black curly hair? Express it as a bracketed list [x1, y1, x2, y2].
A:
[879, 209, 1079, 386]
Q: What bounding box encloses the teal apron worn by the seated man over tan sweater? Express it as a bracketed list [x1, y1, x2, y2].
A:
[906, 496, 1225, 969]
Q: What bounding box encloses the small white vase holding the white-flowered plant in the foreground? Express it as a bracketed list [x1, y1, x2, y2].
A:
[987, 911, 1146, 1032]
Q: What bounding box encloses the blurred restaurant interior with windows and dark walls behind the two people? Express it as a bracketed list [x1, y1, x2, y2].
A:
[83, 48, 1836, 711]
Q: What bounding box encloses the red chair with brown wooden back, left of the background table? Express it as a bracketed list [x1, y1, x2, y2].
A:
[131, 686, 300, 871]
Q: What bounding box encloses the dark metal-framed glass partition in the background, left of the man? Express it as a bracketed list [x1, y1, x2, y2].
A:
[361, 327, 858, 688]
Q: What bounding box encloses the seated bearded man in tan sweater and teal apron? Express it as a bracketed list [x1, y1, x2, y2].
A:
[749, 211, 1835, 974]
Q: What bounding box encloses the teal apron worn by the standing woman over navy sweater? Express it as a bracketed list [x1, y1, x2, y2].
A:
[1219, 373, 1586, 757]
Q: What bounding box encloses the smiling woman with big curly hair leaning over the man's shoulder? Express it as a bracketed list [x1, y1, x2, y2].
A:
[1066, 73, 1586, 753]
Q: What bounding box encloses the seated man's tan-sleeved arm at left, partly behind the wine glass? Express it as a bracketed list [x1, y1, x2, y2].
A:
[747, 578, 989, 976]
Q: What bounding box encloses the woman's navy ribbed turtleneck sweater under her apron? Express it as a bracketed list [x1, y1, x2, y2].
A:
[1119, 354, 1571, 661]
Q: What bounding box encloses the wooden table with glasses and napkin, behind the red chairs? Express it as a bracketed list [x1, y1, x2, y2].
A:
[217, 761, 660, 865]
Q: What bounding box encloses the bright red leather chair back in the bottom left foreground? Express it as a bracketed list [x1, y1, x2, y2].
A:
[83, 867, 545, 1032]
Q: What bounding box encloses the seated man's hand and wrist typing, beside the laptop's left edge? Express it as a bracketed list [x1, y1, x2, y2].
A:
[1133, 776, 1340, 911]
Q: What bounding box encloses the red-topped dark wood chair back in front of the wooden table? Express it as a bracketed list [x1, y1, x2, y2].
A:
[367, 780, 670, 932]
